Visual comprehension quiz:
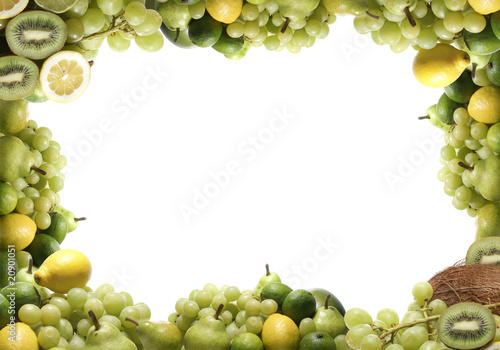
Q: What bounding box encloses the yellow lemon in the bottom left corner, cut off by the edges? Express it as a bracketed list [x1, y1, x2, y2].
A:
[0, 322, 38, 350]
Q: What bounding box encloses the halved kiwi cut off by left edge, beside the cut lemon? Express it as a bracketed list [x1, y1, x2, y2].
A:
[0, 55, 40, 101]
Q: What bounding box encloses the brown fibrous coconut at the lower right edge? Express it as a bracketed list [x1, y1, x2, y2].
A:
[428, 262, 500, 315]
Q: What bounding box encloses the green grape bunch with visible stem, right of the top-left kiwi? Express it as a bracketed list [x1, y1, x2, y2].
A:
[61, 0, 164, 61]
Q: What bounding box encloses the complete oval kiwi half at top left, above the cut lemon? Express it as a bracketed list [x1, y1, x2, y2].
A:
[5, 10, 67, 60]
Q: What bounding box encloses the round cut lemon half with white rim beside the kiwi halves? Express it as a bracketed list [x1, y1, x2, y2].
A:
[40, 51, 90, 103]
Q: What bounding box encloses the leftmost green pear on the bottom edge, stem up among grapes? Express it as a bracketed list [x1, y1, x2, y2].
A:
[82, 310, 138, 350]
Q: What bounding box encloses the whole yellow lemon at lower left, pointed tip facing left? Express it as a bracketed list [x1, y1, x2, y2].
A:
[35, 249, 92, 293]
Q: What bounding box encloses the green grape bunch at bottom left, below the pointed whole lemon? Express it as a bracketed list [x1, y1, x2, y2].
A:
[18, 284, 151, 350]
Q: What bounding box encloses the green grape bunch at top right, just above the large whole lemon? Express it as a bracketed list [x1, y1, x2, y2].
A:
[354, 0, 486, 53]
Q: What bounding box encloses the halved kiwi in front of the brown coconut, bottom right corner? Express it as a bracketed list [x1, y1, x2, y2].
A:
[437, 302, 496, 350]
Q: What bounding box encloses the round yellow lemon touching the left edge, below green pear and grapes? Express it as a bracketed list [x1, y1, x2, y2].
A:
[0, 213, 36, 251]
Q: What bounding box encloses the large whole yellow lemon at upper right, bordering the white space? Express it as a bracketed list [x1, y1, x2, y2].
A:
[413, 43, 470, 88]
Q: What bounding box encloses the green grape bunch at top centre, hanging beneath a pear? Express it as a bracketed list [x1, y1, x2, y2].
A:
[226, 0, 336, 53]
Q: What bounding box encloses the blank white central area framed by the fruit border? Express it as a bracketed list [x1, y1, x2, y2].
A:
[31, 18, 475, 320]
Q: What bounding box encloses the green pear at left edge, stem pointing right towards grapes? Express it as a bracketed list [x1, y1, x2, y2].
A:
[0, 135, 43, 182]
